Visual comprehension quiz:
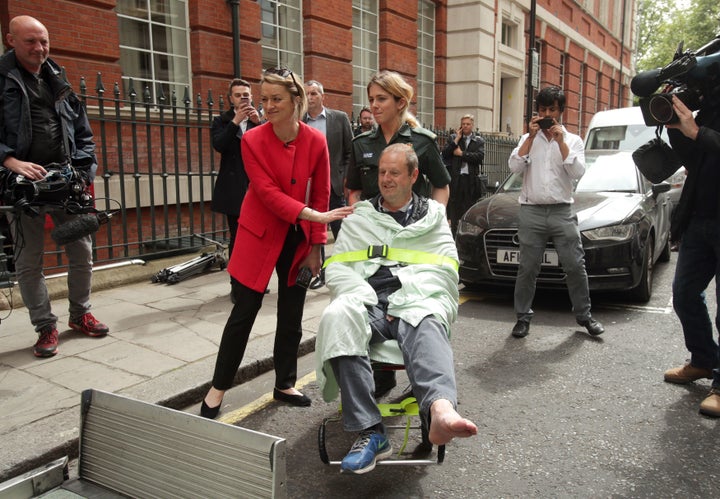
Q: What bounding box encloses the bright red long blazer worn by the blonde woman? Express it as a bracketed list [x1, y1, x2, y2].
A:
[228, 122, 330, 293]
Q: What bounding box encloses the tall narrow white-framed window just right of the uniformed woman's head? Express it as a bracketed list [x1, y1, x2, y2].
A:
[416, 0, 435, 127]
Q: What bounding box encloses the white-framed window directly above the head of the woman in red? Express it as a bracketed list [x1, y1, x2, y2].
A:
[258, 0, 303, 75]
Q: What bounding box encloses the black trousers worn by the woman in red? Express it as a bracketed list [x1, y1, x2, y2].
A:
[212, 226, 307, 390]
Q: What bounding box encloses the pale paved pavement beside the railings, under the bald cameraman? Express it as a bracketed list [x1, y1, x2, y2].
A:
[0, 248, 329, 482]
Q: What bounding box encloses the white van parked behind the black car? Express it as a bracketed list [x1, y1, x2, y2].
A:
[585, 106, 685, 209]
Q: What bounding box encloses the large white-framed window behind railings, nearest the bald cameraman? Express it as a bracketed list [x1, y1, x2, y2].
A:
[115, 0, 192, 104]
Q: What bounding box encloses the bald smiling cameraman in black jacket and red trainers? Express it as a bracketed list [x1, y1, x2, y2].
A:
[0, 16, 108, 357]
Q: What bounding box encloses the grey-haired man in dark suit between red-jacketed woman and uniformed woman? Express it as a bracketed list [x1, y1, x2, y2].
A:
[303, 80, 353, 289]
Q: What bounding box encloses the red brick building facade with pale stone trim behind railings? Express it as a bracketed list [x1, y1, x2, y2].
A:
[0, 0, 635, 267]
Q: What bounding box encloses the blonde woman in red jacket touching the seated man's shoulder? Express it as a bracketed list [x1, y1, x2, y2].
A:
[200, 68, 352, 418]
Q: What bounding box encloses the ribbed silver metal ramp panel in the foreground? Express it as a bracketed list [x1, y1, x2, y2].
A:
[78, 390, 287, 498]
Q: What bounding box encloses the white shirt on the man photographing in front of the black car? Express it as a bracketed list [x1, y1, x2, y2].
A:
[508, 126, 585, 204]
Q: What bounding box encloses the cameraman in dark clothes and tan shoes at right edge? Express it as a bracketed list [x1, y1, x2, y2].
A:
[665, 92, 720, 417]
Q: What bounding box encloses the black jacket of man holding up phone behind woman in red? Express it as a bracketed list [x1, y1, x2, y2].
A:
[210, 109, 257, 215]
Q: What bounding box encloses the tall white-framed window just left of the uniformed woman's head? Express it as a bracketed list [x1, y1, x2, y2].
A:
[352, 0, 378, 119]
